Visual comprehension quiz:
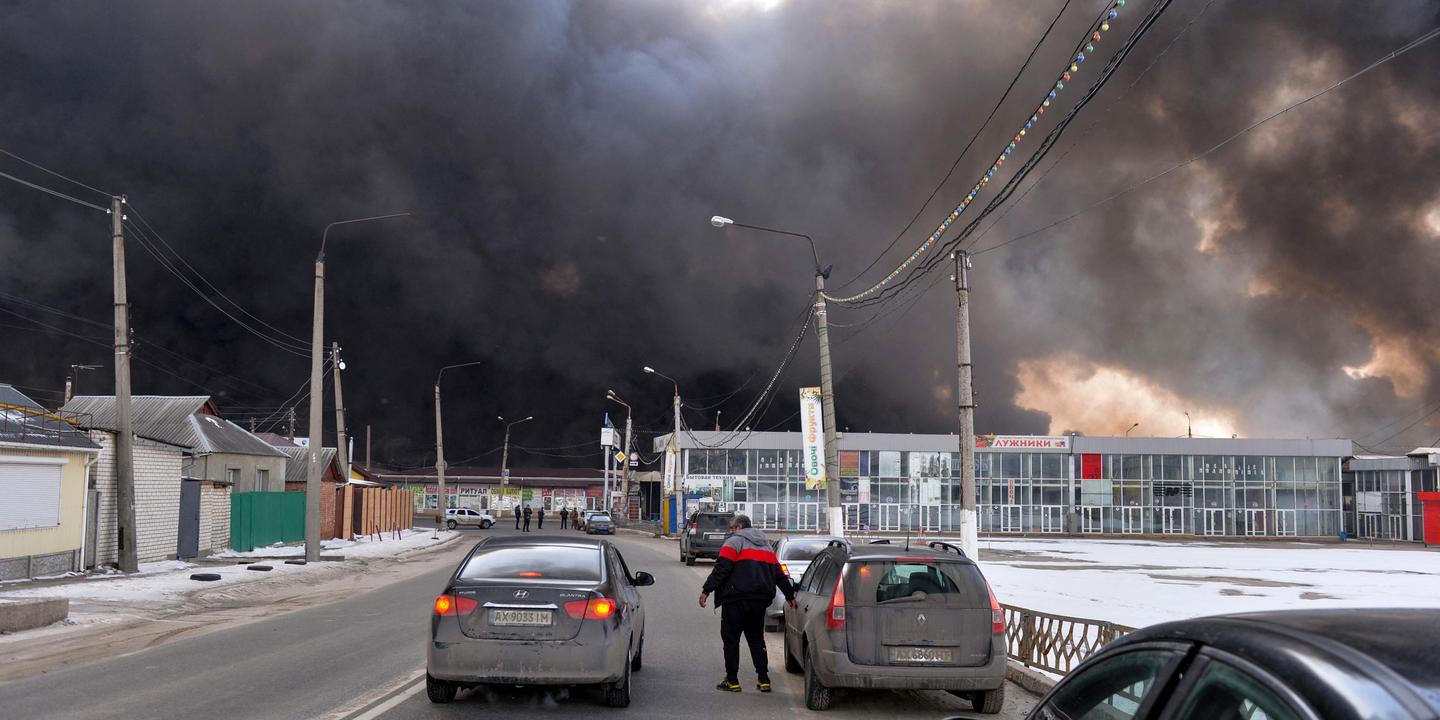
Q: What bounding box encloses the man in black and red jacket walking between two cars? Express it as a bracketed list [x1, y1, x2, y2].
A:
[700, 516, 795, 693]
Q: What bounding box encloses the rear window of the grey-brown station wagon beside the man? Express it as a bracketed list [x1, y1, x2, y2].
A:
[845, 559, 989, 608]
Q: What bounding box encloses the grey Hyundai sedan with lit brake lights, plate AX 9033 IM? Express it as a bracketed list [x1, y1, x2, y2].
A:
[425, 536, 655, 707]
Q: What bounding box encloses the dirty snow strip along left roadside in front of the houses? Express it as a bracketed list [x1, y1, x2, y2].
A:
[0, 528, 458, 603]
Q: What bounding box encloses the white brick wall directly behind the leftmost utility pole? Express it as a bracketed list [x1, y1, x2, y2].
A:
[91, 431, 184, 564]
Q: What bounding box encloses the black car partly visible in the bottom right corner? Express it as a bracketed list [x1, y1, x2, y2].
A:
[956, 609, 1440, 720]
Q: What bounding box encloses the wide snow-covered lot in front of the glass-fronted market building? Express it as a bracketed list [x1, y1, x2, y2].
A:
[981, 539, 1440, 626]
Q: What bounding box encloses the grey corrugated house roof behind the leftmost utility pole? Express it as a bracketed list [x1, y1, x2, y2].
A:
[65, 395, 284, 458]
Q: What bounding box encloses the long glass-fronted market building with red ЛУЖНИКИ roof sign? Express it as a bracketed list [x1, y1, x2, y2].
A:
[654, 432, 1352, 537]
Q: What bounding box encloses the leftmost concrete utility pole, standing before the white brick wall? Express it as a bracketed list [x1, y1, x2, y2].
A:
[109, 197, 140, 573]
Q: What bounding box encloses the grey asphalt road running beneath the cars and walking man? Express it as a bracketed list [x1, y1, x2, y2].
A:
[0, 524, 1034, 720]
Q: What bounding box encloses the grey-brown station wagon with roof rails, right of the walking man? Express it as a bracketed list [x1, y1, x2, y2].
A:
[785, 540, 1007, 713]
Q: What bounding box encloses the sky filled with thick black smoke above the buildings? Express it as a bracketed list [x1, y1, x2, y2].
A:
[0, 0, 1440, 465]
